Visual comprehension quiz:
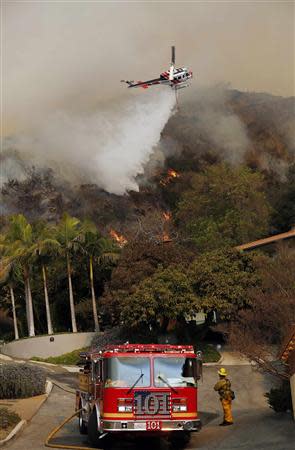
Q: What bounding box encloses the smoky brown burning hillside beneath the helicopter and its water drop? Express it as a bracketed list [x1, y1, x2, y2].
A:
[1, 88, 295, 231]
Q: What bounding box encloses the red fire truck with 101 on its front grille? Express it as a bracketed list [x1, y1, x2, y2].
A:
[76, 344, 202, 448]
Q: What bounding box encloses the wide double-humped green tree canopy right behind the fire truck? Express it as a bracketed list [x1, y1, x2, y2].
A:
[121, 249, 258, 329]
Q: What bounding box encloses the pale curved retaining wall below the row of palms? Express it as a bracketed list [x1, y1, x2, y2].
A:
[0, 333, 96, 359]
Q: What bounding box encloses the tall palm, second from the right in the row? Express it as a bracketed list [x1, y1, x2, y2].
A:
[56, 213, 82, 333]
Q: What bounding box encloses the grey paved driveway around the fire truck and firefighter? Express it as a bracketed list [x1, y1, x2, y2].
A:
[7, 365, 295, 450]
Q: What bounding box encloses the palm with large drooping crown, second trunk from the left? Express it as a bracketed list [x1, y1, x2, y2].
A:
[2, 214, 36, 337]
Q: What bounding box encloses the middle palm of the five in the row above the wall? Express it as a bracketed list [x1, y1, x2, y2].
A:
[34, 222, 60, 334]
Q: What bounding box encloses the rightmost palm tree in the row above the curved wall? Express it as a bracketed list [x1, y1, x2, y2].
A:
[81, 221, 120, 331]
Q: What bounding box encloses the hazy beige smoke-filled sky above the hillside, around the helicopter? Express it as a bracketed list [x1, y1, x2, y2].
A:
[1, 0, 295, 134]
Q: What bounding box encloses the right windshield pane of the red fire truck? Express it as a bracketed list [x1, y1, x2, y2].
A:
[154, 357, 196, 387]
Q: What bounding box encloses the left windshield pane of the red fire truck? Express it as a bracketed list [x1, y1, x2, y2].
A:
[105, 357, 151, 387]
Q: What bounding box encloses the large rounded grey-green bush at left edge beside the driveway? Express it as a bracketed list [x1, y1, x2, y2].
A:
[0, 363, 46, 399]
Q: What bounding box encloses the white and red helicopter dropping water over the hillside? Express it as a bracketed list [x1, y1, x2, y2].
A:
[121, 45, 193, 91]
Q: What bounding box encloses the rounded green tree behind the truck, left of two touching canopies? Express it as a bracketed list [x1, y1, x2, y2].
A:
[121, 266, 201, 331]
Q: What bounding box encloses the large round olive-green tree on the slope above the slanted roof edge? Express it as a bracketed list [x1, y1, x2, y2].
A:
[177, 163, 271, 251]
